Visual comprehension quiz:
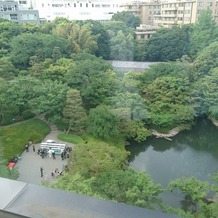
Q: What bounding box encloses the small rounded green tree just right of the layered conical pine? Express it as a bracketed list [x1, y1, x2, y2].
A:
[88, 105, 119, 140]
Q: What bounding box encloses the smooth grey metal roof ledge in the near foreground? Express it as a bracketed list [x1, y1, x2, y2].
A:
[0, 178, 180, 218]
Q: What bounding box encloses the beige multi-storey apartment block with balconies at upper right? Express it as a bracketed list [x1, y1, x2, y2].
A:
[122, 0, 218, 27]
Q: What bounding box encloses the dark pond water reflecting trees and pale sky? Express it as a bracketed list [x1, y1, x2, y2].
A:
[126, 119, 218, 206]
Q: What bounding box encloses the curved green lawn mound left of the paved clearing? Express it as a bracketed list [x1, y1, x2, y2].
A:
[0, 119, 50, 160]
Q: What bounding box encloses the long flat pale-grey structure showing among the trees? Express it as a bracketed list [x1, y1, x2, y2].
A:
[109, 61, 158, 72]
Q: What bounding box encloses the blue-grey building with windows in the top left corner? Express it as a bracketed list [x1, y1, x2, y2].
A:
[0, 0, 39, 23]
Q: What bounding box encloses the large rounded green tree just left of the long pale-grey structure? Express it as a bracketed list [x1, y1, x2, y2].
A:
[66, 54, 116, 108]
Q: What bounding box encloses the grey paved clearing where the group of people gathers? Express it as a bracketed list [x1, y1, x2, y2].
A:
[16, 130, 72, 185]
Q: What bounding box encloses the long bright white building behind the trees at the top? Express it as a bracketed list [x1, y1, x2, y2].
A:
[18, 0, 125, 22]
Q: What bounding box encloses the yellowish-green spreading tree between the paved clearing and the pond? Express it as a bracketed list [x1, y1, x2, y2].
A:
[68, 140, 128, 179]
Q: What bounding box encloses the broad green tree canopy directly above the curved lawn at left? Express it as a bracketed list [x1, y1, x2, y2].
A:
[2, 76, 68, 121]
